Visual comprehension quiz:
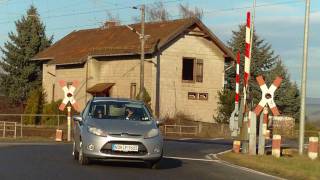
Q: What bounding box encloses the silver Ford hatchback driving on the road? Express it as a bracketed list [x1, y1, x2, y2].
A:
[72, 97, 163, 168]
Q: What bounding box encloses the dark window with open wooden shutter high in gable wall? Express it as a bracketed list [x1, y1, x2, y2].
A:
[182, 58, 203, 82]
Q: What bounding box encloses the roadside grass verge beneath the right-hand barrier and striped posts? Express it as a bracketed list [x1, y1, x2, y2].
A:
[218, 152, 320, 180]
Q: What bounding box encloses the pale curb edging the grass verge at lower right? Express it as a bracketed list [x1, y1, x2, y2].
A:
[206, 149, 286, 180]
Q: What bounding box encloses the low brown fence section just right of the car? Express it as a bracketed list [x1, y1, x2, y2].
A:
[164, 125, 198, 136]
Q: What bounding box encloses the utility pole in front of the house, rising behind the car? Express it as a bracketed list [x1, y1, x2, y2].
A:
[139, 4, 145, 100]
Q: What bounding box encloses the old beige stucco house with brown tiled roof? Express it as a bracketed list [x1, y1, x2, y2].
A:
[33, 18, 234, 122]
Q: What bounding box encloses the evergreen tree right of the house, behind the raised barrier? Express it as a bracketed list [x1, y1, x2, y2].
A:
[215, 25, 300, 122]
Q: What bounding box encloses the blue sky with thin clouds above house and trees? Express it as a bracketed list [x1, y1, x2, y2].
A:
[0, 0, 320, 98]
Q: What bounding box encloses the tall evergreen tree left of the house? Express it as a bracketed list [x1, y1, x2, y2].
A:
[0, 6, 53, 102]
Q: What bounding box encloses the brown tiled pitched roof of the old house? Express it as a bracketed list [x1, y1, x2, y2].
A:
[32, 18, 235, 64]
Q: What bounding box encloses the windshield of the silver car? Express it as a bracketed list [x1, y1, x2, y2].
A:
[89, 101, 150, 121]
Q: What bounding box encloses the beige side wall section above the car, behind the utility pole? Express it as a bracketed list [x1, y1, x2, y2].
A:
[88, 58, 154, 101]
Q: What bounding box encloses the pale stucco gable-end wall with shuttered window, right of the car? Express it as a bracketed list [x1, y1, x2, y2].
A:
[160, 35, 224, 122]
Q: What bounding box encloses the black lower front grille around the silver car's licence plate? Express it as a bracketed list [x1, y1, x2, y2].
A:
[100, 141, 148, 156]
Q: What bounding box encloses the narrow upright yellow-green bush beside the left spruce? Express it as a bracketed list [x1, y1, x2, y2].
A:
[23, 87, 45, 124]
